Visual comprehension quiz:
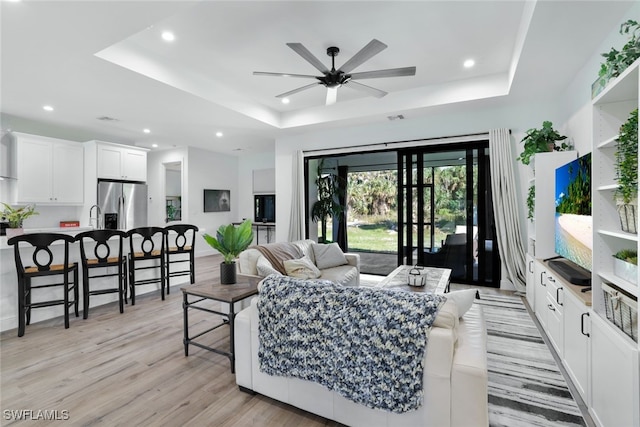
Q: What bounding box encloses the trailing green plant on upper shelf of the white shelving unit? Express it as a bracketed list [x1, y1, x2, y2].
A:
[614, 108, 638, 204]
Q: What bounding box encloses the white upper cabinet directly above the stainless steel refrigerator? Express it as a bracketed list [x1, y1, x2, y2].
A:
[97, 143, 147, 182]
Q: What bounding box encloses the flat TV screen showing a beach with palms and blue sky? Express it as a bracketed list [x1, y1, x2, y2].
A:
[555, 153, 593, 271]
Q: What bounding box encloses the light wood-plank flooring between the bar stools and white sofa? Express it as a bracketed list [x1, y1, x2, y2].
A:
[0, 256, 339, 427]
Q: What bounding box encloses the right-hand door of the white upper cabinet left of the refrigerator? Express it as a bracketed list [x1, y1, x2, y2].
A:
[53, 144, 84, 204]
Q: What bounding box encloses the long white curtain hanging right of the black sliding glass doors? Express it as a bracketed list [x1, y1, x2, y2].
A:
[489, 129, 526, 292]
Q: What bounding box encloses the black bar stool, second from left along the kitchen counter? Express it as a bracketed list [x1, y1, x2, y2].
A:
[76, 230, 127, 319]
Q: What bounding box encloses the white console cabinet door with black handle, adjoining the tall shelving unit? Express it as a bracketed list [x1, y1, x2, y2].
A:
[563, 292, 591, 404]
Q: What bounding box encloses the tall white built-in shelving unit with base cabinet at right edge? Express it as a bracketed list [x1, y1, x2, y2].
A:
[588, 56, 640, 426]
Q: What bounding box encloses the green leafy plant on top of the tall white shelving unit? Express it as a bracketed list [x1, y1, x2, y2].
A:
[591, 19, 640, 97]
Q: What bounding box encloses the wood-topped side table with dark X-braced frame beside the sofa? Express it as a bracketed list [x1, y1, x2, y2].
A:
[181, 280, 258, 372]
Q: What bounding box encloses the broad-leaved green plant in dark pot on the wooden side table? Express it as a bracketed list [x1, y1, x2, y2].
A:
[203, 220, 253, 285]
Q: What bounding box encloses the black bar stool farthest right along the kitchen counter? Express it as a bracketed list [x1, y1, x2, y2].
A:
[164, 224, 198, 294]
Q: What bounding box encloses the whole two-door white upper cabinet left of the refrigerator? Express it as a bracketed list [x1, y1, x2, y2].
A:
[15, 132, 84, 205]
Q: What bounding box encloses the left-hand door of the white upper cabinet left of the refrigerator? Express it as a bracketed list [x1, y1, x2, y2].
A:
[17, 136, 53, 203]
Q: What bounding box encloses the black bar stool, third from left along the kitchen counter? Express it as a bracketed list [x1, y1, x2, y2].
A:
[127, 227, 168, 305]
